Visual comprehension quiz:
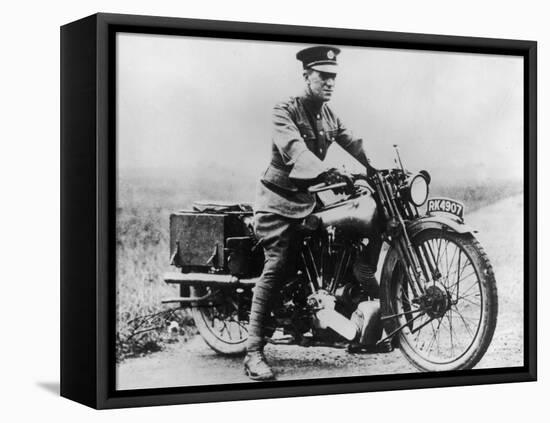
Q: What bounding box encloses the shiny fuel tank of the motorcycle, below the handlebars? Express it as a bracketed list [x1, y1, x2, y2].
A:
[314, 192, 380, 238]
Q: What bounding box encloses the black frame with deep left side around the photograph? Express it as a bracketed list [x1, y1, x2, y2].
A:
[61, 13, 537, 409]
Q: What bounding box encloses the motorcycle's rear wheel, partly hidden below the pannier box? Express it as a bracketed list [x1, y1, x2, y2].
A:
[191, 288, 248, 355]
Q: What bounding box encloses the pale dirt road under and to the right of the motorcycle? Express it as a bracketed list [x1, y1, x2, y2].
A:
[117, 195, 523, 389]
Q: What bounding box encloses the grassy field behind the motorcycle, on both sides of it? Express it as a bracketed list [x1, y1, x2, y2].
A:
[116, 169, 522, 360]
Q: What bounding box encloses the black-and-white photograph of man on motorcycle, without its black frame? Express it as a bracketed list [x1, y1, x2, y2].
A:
[114, 31, 526, 391]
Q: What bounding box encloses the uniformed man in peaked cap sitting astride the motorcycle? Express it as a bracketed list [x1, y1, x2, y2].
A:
[244, 46, 381, 380]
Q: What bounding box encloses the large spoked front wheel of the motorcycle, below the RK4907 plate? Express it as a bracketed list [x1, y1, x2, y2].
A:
[382, 229, 498, 372]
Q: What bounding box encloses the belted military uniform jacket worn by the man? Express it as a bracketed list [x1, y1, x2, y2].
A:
[254, 96, 367, 218]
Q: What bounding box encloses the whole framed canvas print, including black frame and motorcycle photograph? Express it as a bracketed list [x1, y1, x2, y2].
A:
[61, 14, 536, 408]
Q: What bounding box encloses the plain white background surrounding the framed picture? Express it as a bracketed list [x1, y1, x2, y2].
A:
[0, 0, 550, 422]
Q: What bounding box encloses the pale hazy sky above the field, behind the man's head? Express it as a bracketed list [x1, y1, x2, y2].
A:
[117, 34, 523, 185]
